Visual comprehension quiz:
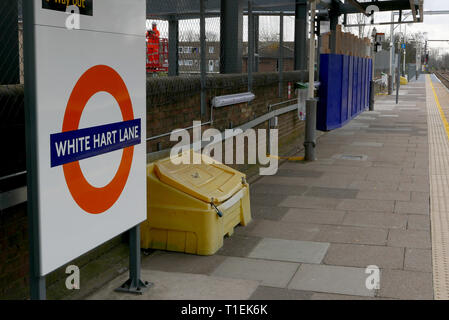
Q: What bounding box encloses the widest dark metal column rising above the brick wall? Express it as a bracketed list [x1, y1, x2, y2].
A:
[220, 0, 243, 73]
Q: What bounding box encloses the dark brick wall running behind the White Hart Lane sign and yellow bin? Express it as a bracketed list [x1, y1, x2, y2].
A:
[0, 72, 307, 299]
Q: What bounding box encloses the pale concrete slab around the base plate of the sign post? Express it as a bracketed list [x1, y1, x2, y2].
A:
[87, 270, 259, 300]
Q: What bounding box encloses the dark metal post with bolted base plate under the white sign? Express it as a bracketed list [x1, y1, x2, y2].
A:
[115, 224, 153, 294]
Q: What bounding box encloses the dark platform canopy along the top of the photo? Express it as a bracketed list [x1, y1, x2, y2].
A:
[147, 0, 424, 22]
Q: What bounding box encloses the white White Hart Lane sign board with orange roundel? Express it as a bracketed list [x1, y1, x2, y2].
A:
[28, 0, 146, 276]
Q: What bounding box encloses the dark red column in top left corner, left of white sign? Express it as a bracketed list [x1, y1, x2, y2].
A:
[0, 0, 20, 85]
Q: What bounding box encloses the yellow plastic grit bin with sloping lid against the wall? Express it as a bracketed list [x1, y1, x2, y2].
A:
[141, 152, 251, 255]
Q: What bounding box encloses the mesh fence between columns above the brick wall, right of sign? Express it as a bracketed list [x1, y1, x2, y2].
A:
[147, 0, 295, 76]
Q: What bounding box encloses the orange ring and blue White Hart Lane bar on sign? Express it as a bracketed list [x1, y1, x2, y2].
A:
[51, 65, 136, 214]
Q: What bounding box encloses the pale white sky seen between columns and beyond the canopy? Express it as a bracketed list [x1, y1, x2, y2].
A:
[147, 0, 449, 53]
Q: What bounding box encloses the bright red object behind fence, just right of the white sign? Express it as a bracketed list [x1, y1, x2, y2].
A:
[147, 23, 168, 73]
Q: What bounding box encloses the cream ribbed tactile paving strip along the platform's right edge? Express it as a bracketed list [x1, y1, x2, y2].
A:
[426, 76, 449, 300]
